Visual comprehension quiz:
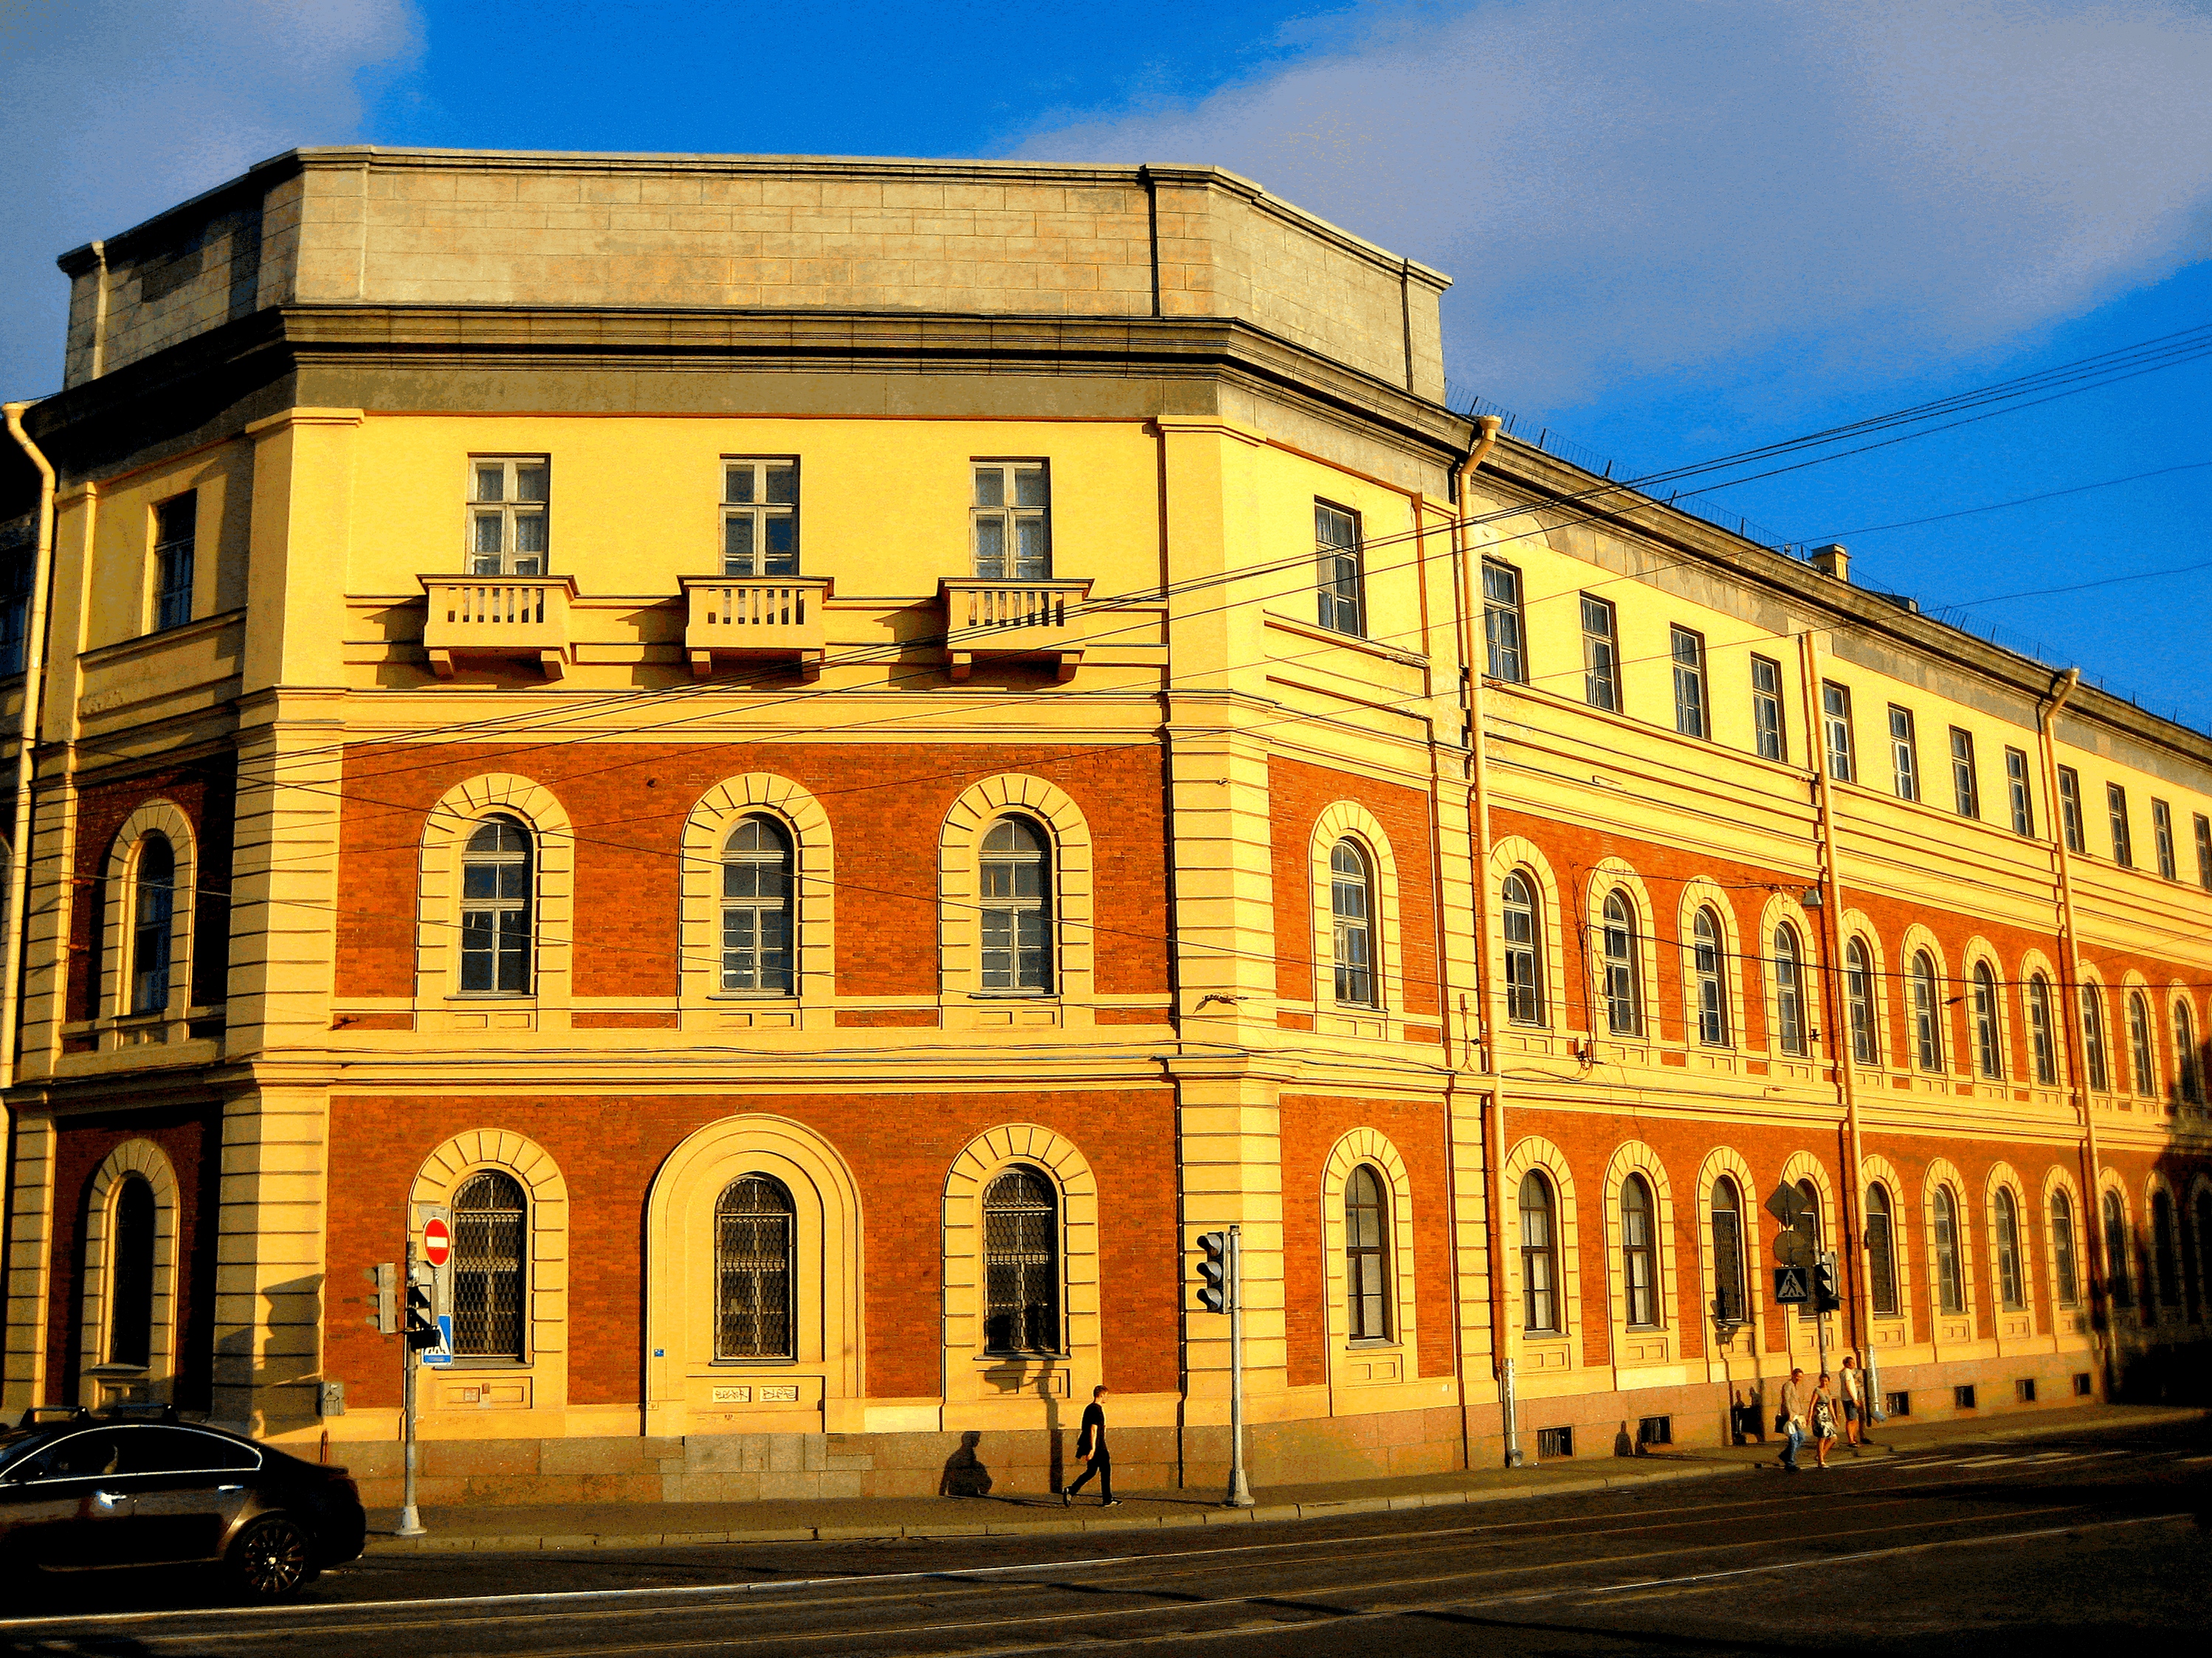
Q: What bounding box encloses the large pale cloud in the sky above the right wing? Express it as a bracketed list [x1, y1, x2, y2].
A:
[1020, 0, 2212, 407]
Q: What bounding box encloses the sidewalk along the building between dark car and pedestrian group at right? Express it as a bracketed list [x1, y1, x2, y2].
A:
[369, 1457, 1748, 1554]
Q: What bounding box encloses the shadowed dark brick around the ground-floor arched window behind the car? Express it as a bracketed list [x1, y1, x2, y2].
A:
[46, 1108, 224, 1410]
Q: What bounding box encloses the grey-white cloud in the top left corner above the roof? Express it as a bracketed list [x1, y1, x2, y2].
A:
[0, 0, 416, 398]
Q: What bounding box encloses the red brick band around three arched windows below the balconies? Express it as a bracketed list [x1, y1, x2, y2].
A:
[339, 743, 1168, 997]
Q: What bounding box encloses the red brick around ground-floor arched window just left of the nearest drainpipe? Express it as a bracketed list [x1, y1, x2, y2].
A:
[1281, 1094, 1453, 1386]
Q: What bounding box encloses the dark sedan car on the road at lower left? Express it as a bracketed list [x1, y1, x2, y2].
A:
[0, 1412, 365, 1600]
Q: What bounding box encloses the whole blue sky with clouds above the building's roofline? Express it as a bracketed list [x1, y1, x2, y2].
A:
[0, 0, 2212, 730]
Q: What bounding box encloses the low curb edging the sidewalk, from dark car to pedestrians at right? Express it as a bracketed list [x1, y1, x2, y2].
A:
[365, 1463, 1752, 1554]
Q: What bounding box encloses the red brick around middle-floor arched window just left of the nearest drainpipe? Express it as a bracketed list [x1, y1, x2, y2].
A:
[1267, 756, 1438, 1019]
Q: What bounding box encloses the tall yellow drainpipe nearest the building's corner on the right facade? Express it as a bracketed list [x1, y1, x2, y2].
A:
[1451, 415, 1522, 1468]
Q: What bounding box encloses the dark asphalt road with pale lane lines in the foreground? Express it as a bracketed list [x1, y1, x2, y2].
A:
[0, 1423, 2212, 1658]
